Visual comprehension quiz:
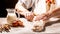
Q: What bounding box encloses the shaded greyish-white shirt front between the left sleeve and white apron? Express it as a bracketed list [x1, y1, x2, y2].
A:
[17, 0, 35, 9]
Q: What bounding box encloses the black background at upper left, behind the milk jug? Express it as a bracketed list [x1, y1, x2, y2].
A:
[0, 0, 18, 17]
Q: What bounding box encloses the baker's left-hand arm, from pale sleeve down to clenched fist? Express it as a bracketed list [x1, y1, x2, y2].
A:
[15, 3, 34, 21]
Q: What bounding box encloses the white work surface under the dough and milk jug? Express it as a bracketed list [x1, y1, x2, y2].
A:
[0, 18, 60, 34]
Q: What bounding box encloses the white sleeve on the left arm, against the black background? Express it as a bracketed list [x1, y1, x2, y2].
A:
[15, 0, 28, 14]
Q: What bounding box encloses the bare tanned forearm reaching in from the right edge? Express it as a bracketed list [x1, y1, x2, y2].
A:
[42, 8, 60, 21]
